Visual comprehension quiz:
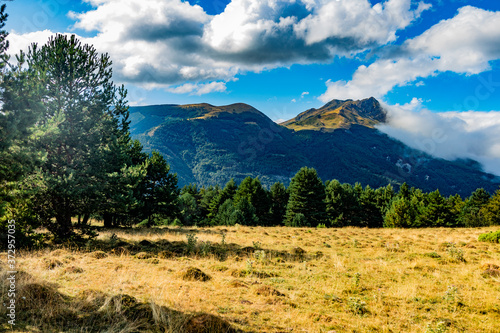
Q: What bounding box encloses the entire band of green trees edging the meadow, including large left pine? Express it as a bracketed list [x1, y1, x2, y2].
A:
[0, 5, 500, 244]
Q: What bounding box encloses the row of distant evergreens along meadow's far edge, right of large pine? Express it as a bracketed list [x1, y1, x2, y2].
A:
[173, 167, 500, 228]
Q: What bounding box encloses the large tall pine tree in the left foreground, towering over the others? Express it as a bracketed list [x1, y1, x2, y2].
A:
[11, 35, 138, 238]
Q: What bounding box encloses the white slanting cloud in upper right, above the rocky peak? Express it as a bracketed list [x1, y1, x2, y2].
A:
[320, 6, 500, 102]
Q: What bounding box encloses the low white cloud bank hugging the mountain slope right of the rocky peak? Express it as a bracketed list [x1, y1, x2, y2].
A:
[378, 98, 500, 175]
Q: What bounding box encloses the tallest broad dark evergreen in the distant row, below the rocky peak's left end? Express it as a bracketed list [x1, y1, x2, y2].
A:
[286, 167, 326, 227]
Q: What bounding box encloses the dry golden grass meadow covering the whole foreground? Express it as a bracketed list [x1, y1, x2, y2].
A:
[0, 226, 500, 333]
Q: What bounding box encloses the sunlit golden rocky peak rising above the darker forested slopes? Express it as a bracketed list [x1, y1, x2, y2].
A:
[281, 97, 386, 131]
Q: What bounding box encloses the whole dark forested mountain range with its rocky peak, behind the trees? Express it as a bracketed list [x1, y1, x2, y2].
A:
[130, 98, 499, 196]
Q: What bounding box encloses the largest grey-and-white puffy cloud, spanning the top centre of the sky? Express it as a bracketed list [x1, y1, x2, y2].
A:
[6, 0, 429, 93]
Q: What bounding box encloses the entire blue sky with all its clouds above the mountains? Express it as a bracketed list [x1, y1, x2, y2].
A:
[6, 0, 500, 174]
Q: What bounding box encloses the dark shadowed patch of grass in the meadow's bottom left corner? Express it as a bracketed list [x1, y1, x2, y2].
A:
[0, 271, 239, 333]
